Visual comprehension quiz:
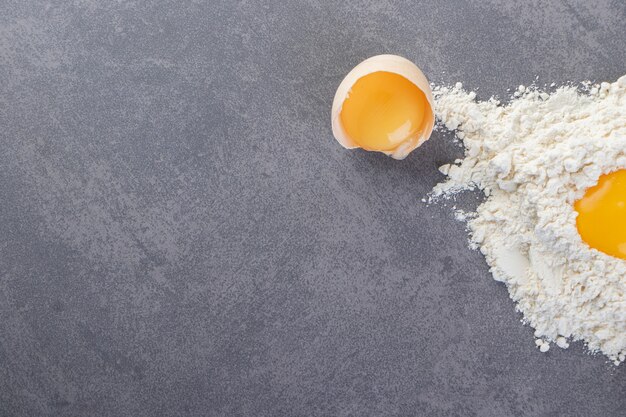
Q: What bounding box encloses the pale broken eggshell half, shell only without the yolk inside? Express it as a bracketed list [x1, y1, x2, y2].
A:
[331, 55, 435, 159]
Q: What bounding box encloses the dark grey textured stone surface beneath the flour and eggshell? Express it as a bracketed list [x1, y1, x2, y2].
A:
[0, 0, 626, 417]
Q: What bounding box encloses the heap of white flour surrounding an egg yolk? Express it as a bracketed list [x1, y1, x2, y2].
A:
[432, 76, 626, 364]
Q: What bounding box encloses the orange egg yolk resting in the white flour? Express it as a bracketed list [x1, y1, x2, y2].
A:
[574, 169, 626, 259]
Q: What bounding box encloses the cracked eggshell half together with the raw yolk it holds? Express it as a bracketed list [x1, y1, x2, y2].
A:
[332, 55, 435, 159]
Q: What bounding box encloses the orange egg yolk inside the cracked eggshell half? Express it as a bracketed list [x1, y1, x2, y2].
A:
[340, 71, 431, 151]
